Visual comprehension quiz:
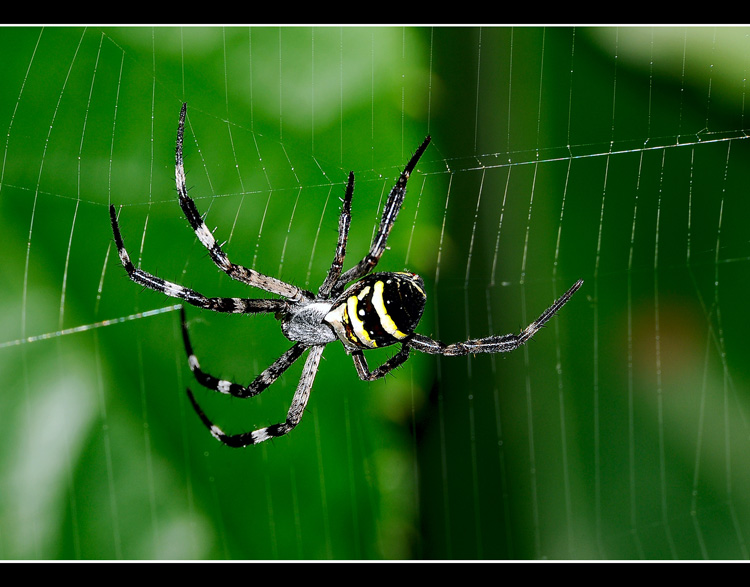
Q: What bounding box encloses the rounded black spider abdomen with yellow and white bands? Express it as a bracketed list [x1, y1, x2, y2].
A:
[325, 272, 427, 351]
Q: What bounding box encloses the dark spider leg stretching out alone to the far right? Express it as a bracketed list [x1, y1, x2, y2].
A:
[408, 279, 583, 356]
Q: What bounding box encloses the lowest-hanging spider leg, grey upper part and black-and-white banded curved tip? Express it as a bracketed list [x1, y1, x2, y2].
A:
[187, 345, 325, 448]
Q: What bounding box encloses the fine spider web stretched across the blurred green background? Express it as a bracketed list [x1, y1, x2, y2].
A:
[0, 27, 750, 559]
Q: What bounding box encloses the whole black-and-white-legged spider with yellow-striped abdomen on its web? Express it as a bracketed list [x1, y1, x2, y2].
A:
[109, 104, 583, 447]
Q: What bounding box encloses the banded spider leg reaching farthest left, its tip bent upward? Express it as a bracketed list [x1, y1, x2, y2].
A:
[109, 206, 289, 314]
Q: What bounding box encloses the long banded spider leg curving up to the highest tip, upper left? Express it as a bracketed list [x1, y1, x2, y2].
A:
[175, 104, 313, 301]
